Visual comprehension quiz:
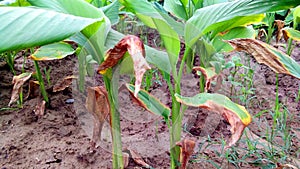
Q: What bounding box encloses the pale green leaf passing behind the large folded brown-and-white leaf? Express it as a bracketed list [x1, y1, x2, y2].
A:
[105, 30, 171, 73]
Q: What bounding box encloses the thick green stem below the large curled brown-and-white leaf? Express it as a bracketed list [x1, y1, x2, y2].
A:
[103, 76, 124, 169]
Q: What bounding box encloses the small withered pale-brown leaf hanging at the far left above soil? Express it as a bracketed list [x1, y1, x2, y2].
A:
[8, 73, 32, 106]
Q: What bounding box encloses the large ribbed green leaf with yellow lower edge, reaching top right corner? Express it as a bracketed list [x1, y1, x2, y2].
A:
[185, 0, 300, 46]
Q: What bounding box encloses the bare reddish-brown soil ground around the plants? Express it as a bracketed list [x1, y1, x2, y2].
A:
[0, 37, 300, 169]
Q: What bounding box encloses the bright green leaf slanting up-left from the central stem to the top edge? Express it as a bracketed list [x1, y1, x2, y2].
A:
[121, 0, 180, 70]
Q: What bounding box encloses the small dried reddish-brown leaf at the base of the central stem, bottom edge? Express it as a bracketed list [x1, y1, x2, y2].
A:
[176, 139, 195, 169]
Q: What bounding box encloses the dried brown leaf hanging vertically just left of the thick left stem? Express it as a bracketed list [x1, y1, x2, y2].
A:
[86, 86, 110, 146]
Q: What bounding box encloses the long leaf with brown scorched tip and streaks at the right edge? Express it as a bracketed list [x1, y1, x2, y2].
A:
[227, 39, 300, 79]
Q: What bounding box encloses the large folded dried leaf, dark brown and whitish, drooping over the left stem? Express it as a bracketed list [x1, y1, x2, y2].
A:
[98, 35, 151, 97]
